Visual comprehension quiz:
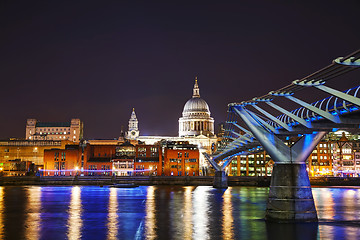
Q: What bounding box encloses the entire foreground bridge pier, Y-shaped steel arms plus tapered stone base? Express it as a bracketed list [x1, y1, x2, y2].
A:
[234, 107, 326, 222]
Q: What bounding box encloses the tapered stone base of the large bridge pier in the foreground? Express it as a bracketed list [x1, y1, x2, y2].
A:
[265, 164, 318, 222]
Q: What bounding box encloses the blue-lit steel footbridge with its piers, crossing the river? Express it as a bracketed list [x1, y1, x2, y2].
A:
[205, 49, 360, 222]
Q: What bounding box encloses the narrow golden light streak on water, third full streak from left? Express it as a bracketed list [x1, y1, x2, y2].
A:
[107, 188, 119, 240]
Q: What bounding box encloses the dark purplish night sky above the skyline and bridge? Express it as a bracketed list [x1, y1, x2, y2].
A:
[0, 0, 360, 139]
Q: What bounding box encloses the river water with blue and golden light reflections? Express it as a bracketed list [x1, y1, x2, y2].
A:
[0, 186, 360, 240]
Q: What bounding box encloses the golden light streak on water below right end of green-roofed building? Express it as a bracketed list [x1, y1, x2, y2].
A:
[67, 186, 82, 239]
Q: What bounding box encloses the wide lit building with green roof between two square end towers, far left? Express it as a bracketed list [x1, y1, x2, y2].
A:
[26, 119, 83, 143]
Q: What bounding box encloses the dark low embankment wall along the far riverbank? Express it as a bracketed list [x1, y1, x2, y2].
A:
[0, 176, 360, 187]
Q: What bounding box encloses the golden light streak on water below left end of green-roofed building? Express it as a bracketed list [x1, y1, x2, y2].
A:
[25, 187, 41, 239]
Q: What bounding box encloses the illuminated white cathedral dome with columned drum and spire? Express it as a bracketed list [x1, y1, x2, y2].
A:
[179, 78, 214, 137]
